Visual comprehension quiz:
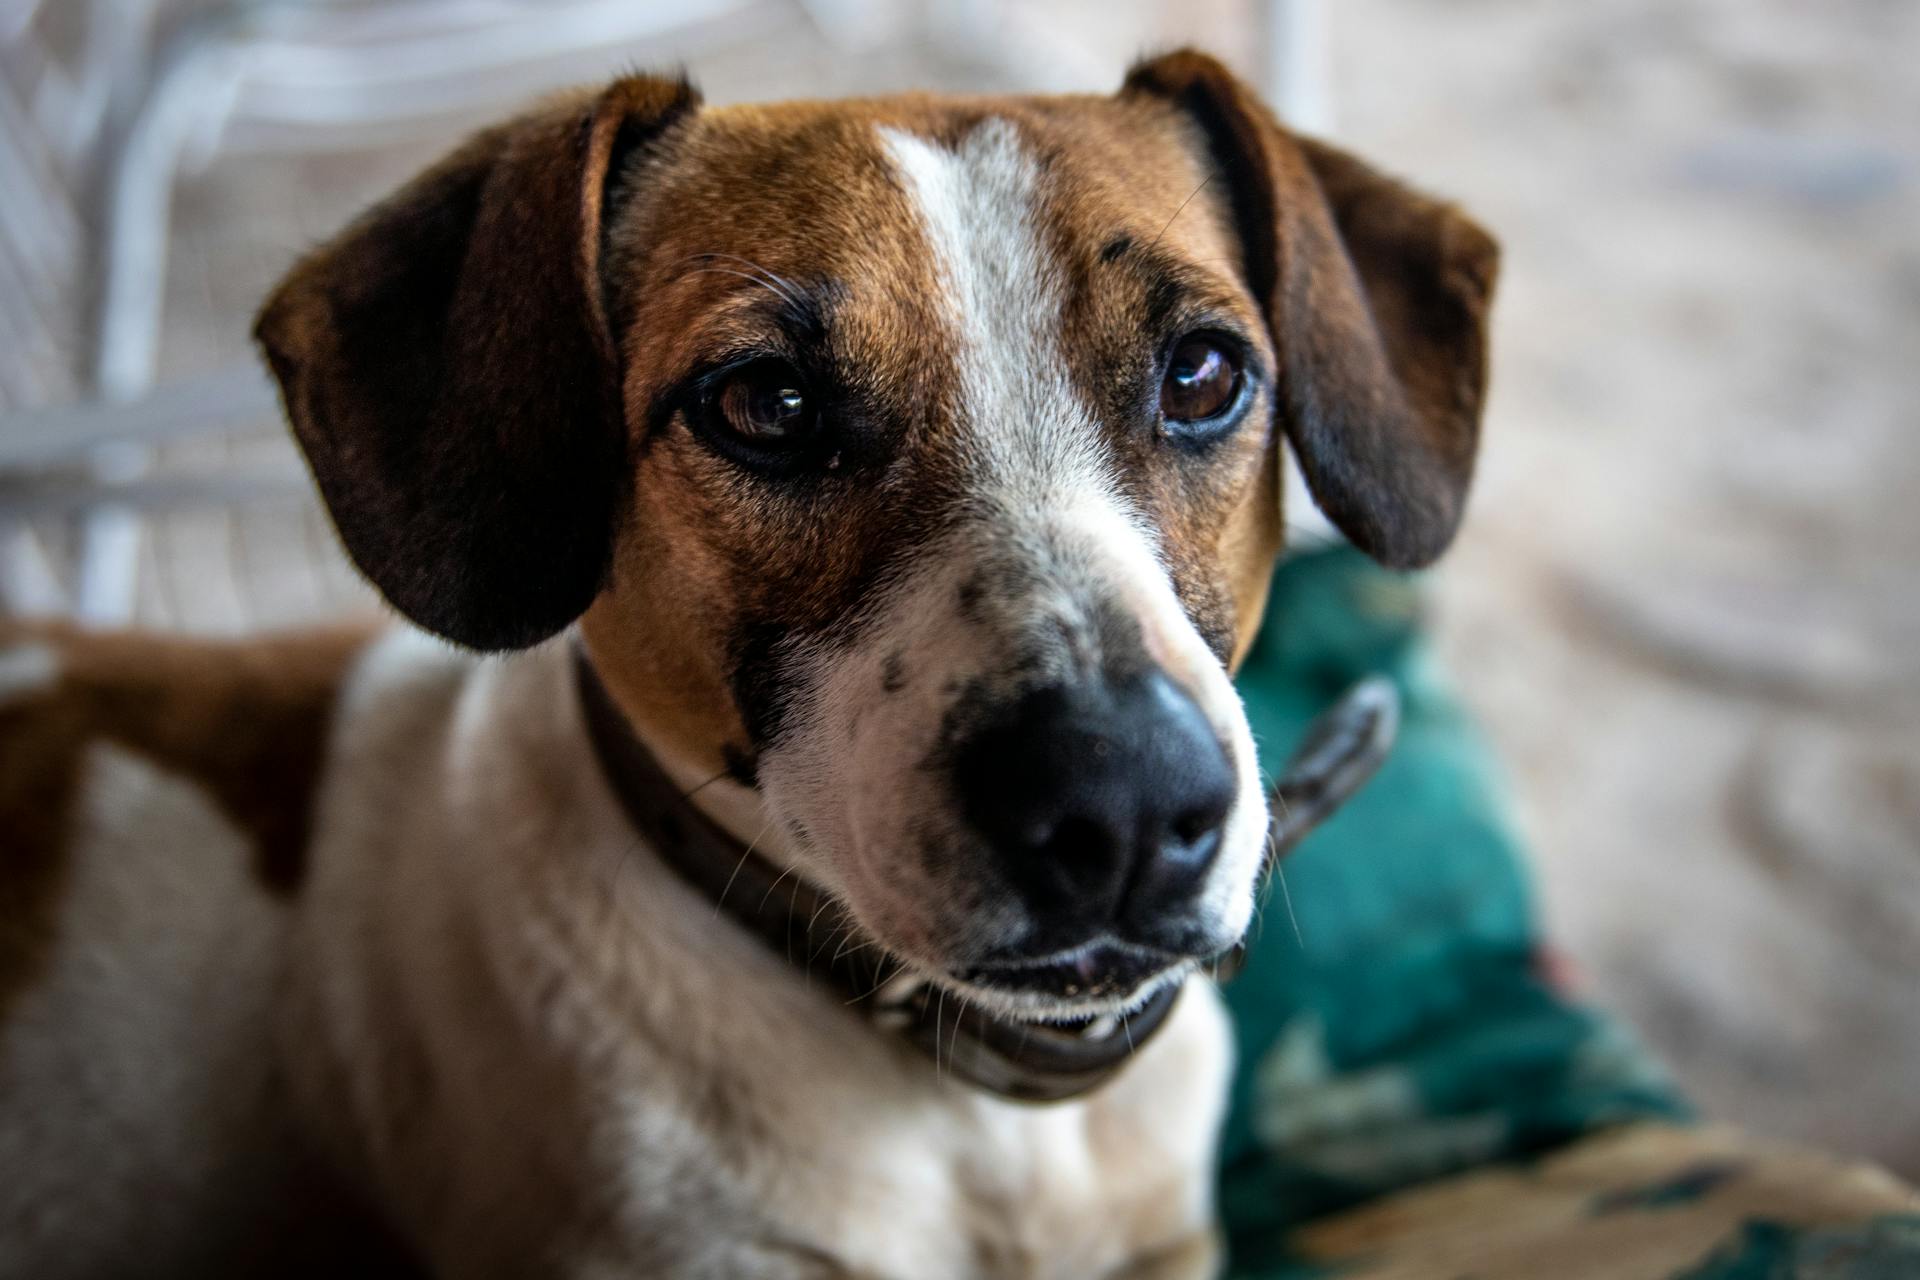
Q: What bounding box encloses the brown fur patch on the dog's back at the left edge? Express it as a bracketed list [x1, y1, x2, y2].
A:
[0, 624, 369, 1015]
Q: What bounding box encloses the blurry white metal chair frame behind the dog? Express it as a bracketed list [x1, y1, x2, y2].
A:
[0, 0, 1332, 624]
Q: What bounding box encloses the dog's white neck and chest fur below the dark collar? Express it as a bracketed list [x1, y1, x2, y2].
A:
[296, 637, 1229, 1280]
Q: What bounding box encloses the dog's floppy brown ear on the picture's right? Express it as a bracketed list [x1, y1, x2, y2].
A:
[1121, 50, 1500, 568]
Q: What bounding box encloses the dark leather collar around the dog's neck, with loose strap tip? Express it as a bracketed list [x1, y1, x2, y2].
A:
[572, 643, 1398, 1102]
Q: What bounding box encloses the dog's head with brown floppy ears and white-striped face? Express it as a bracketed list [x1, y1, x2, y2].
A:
[259, 54, 1496, 1017]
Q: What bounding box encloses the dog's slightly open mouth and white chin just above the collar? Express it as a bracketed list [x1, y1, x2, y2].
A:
[931, 938, 1198, 1023]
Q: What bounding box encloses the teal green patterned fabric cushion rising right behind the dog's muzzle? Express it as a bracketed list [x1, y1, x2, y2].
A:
[1221, 547, 1684, 1280]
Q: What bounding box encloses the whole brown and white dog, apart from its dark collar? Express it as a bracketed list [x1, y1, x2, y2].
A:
[0, 52, 1496, 1280]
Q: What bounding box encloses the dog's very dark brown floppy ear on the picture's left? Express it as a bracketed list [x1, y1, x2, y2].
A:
[253, 77, 699, 649]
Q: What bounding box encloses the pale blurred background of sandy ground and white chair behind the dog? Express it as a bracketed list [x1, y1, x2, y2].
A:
[0, 0, 1920, 1174]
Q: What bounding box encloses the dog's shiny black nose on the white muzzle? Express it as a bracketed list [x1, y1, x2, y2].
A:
[956, 672, 1235, 952]
